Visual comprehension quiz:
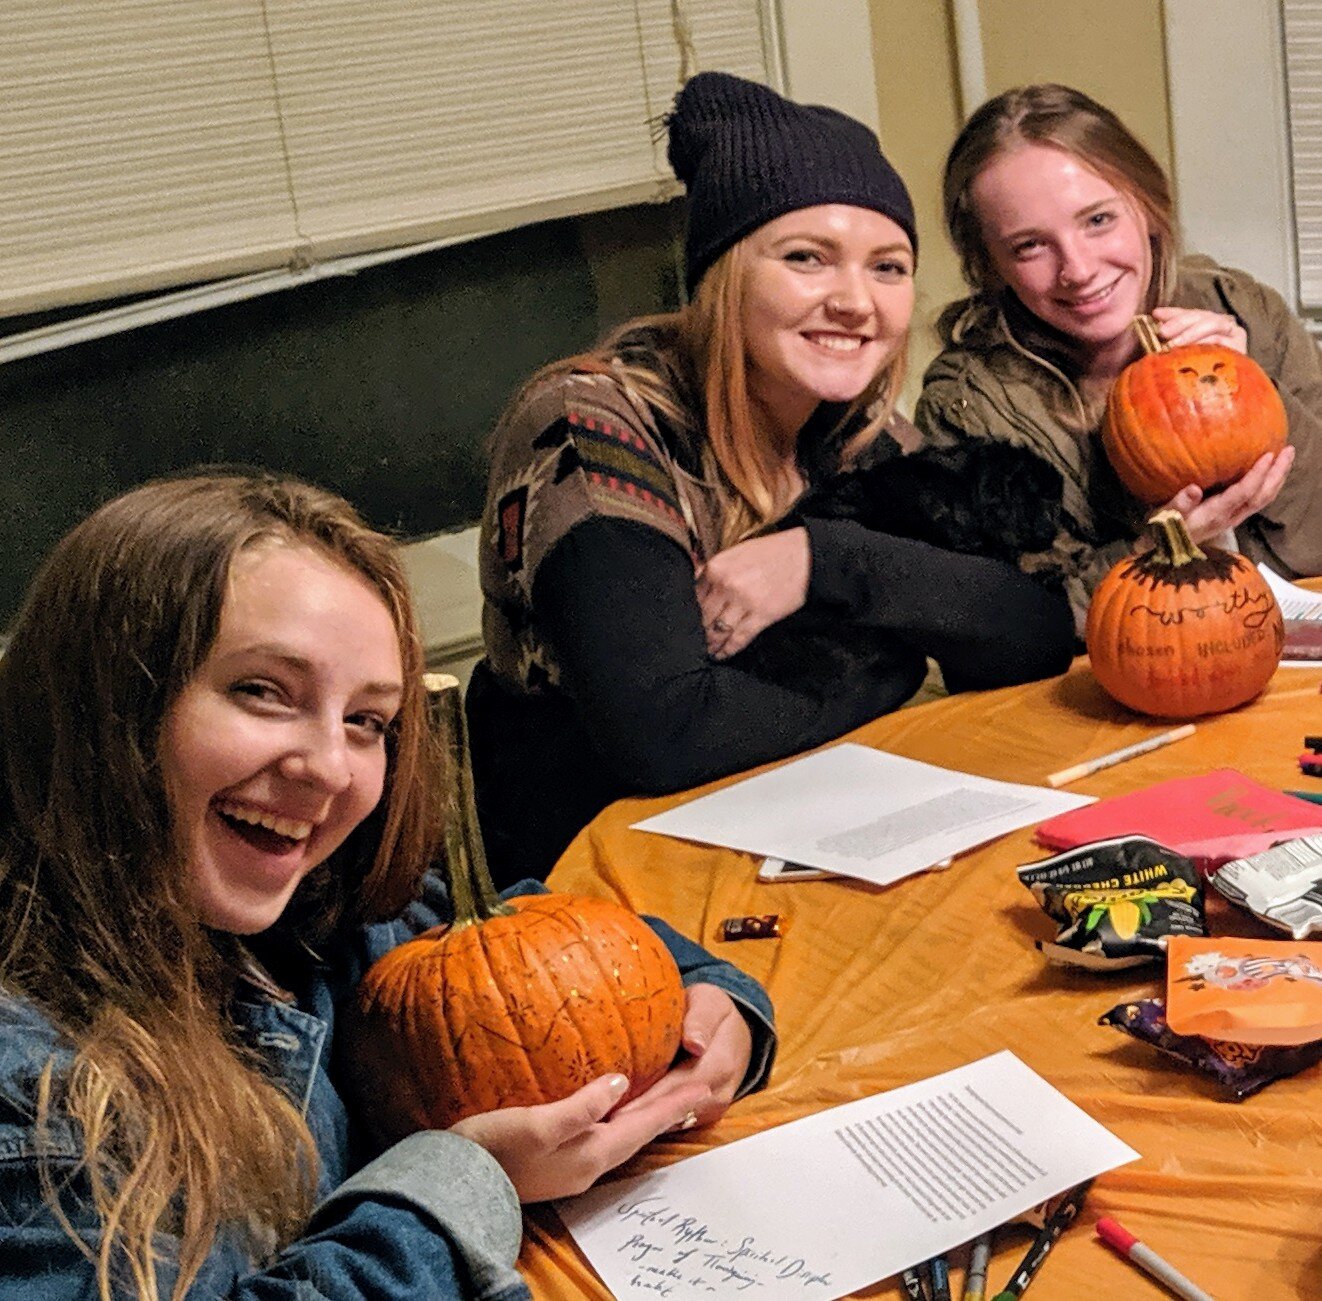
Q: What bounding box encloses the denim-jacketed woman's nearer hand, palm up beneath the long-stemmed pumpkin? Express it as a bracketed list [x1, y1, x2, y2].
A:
[451, 1068, 708, 1202]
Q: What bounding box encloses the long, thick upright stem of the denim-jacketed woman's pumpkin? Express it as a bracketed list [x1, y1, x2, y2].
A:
[423, 673, 514, 931]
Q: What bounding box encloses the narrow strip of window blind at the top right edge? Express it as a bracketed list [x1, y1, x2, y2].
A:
[1281, 0, 1322, 311]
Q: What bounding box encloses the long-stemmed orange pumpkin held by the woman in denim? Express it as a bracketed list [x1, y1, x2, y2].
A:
[345, 678, 685, 1142]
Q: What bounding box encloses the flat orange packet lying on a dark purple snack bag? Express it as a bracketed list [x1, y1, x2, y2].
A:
[1166, 935, 1322, 1045]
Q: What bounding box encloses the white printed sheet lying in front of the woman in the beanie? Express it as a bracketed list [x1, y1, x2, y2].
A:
[635, 743, 1093, 885]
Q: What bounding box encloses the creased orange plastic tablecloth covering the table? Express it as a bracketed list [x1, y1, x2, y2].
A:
[520, 660, 1322, 1301]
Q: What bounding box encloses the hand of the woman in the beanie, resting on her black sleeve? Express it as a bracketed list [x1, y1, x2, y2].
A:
[697, 528, 812, 660]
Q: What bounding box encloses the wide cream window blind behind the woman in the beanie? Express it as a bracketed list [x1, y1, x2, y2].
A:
[0, 0, 777, 315]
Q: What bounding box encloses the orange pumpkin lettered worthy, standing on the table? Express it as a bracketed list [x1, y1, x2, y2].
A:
[1084, 510, 1285, 718]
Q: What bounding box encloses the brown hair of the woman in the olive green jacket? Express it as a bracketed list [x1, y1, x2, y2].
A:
[941, 82, 1178, 308]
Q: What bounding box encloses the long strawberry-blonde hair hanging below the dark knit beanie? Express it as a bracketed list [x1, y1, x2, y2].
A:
[497, 241, 908, 547]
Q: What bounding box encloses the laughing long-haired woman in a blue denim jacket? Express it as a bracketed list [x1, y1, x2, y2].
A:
[0, 475, 772, 1301]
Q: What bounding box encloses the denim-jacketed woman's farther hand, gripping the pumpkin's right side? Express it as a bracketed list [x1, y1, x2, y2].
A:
[616, 984, 752, 1129]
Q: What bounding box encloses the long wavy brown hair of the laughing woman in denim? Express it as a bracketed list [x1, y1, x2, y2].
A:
[0, 472, 439, 1301]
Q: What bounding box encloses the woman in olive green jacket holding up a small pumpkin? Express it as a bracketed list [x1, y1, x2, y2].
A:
[915, 85, 1322, 627]
